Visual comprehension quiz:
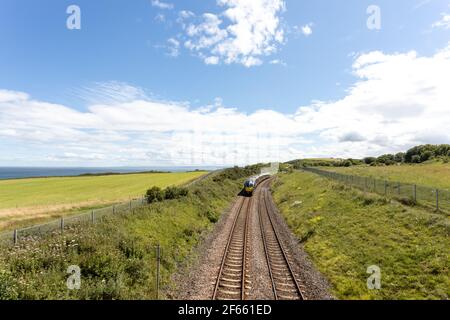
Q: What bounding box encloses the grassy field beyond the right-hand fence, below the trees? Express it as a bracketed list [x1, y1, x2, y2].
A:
[323, 162, 450, 190]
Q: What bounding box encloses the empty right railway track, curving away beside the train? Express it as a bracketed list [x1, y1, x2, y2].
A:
[259, 182, 305, 300]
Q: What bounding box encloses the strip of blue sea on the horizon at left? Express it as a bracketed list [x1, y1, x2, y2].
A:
[0, 167, 220, 180]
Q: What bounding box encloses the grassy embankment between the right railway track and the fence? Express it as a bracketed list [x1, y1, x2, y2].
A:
[274, 171, 450, 299]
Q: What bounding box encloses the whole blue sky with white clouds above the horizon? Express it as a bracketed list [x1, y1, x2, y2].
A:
[0, 0, 450, 167]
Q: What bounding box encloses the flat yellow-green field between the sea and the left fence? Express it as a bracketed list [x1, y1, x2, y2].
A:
[0, 172, 205, 230]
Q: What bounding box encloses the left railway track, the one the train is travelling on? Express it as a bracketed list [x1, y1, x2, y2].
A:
[213, 197, 252, 300]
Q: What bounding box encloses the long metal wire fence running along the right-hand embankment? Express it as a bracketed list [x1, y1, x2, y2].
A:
[303, 168, 450, 213]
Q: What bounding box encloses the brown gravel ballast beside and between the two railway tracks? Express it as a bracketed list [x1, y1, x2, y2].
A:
[168, 179, 332, 300]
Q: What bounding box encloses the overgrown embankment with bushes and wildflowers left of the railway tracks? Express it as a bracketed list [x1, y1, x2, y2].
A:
[0, 168, 256, 299]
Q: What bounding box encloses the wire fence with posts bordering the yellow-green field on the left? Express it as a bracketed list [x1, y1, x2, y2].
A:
[0, 170, 215, 245]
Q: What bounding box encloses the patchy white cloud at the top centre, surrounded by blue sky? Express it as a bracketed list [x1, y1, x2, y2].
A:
[179, 0, 285, 67]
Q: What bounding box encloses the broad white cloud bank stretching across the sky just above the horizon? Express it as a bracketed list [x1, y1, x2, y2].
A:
[0, 44, 450, 165]
